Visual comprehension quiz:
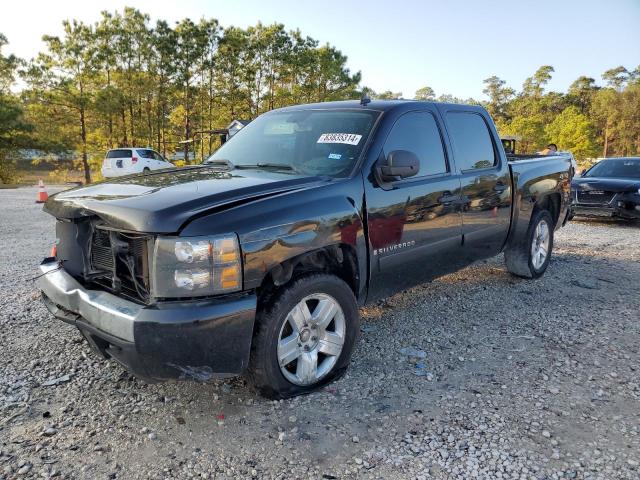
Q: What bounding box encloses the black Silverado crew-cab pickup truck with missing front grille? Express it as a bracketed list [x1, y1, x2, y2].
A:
[38, 101, 572, 398]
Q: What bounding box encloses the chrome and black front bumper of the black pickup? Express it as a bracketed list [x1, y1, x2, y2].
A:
[38, 259, 257, 380]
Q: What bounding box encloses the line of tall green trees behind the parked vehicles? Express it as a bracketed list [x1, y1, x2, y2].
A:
[0, 8, 640, 182]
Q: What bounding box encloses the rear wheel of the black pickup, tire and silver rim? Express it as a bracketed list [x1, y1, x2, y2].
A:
[504, 210, 554, 278]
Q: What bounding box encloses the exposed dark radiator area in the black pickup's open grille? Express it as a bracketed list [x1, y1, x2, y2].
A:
[89, 226, 150, 303]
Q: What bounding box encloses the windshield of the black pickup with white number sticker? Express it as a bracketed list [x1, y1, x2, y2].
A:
[205, 110, 379, 177]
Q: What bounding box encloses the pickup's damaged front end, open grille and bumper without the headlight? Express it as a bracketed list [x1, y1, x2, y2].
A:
[38, 215, 256, 381]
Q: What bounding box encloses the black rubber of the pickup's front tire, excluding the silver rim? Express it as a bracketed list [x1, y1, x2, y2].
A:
[250, 275, 360, 398]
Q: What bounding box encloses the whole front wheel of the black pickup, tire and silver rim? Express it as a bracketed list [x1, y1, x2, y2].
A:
[247, 274, 360, 399]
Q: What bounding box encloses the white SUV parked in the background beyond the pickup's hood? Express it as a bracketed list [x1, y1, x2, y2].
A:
[102, 148, 174, 178]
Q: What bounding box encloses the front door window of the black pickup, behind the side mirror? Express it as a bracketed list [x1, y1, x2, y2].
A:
[383, 112, 447, 178]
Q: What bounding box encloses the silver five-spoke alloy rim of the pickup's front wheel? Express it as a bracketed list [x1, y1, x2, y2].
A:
[278, 293, 346, 385]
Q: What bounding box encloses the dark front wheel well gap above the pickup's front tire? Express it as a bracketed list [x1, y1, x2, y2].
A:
[258, 244, 360, 308]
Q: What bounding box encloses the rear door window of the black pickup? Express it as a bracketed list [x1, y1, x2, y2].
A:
[447, 112, 496, 170]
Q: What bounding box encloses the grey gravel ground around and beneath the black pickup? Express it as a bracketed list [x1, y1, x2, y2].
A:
[0, 188, 640, 479]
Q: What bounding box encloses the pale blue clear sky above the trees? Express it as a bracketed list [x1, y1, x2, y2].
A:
[0, 0, 640, 99]
